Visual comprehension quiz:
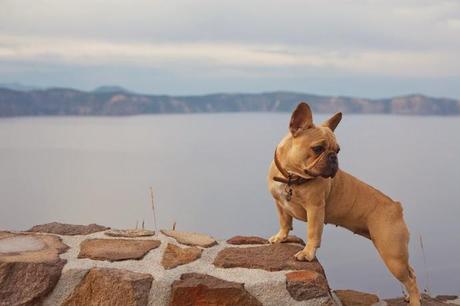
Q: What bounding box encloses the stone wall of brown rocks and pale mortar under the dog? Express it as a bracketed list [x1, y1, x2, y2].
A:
[0, 223, 460, 306]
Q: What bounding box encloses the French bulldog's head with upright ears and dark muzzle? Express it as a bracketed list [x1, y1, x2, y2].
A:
[287, 102, 342, 178]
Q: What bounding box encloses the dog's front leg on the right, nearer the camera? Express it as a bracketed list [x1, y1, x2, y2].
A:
[294, 203, 326, 261]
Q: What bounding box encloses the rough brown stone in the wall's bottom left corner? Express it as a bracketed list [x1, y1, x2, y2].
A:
[0, 259, 66, 306]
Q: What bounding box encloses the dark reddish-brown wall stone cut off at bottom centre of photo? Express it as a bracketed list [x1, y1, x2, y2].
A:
[169, 273, 262, 306]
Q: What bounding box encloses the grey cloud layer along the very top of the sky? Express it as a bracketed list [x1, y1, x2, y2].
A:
[0, 0, 460, 50]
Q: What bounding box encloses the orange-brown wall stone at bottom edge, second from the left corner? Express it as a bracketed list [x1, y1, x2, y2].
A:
[62, 268, 153, 306]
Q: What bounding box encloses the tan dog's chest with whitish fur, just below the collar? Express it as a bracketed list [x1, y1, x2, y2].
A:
[273, 182, 307, 221]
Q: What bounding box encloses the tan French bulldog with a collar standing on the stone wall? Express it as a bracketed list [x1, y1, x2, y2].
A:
[268, 102, 420, 305]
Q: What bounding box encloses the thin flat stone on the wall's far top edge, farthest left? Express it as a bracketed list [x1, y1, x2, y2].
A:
[28, 222, 110, 236]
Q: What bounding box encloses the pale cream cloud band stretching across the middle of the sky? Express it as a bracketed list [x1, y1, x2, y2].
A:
[0, 35, 460, 77]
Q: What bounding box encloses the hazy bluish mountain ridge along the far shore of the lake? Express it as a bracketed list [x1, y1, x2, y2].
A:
[0, 86, 460, 117]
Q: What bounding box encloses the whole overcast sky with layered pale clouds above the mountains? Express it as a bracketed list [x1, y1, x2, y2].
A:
[0, 0, 460, 98]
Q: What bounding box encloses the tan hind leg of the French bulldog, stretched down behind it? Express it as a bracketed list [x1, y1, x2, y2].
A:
[371, 220, 420, 306]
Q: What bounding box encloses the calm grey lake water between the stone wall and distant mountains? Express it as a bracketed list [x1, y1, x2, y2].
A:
[0, 113, 460, 297]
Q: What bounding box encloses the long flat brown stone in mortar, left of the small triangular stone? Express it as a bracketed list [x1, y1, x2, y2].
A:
[78, 239, 161, 261]
